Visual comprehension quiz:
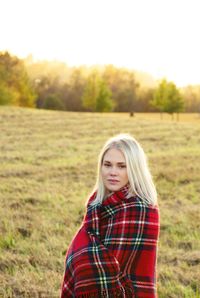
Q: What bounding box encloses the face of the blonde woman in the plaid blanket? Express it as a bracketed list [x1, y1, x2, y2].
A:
[101, 148, 128, 191]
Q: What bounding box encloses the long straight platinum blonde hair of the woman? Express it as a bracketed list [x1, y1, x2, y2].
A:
[91, 134, 157, 205]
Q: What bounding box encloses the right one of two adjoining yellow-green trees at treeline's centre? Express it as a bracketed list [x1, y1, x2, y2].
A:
[96, 81, 113, 112]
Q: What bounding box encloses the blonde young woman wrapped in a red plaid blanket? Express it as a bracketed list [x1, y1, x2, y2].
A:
[61, 134, 159, 298]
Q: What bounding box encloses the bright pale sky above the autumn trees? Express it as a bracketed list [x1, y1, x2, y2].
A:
[0, 0, 200, 86]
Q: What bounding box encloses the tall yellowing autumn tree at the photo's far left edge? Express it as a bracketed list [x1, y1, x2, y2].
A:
[0, 52, 36, 107]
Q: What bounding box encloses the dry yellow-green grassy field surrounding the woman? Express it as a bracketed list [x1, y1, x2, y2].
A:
[0, 107, 200, 298]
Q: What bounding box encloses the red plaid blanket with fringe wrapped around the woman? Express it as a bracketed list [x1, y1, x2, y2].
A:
[61, 187, 159, 298]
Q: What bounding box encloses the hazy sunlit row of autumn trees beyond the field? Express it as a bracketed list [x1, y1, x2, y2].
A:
[0, 52, 200, 114]
